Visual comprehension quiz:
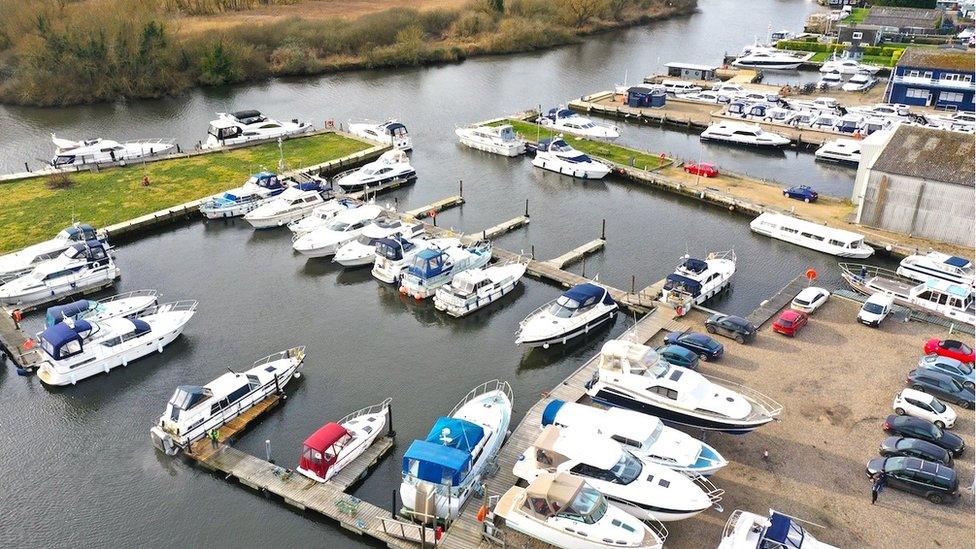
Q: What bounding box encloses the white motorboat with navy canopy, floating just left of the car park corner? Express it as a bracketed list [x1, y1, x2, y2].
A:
[515, 282, 619, 349]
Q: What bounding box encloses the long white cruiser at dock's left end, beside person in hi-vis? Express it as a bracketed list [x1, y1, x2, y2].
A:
[149, 347, 305, 455]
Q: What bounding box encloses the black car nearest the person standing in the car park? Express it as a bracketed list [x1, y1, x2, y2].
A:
[867, 457, 959, 503]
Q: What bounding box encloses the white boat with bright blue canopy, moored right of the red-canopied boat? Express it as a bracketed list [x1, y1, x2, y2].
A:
[400, 380, 513, 523]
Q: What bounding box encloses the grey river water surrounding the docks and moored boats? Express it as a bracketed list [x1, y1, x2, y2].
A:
[0, 0, 892, 547]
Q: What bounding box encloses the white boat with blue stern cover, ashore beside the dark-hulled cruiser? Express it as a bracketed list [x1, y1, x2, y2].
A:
[542, 400, 728, 476]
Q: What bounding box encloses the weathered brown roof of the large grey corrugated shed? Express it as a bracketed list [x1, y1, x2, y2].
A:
[871, 125, 976, 187]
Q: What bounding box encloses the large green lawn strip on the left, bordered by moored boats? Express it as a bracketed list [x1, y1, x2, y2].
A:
[0, 133, 371, 253]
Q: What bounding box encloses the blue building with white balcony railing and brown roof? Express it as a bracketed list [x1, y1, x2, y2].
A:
[885, 48, 976, 111]
